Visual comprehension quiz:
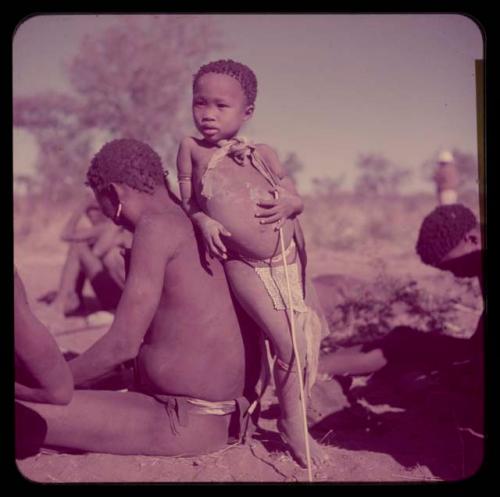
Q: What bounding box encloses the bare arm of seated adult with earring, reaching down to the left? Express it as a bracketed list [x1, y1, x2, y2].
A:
[69, 214, 175, 385]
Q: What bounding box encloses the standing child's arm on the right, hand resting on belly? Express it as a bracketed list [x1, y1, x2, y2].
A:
[256, 145, 304, 229]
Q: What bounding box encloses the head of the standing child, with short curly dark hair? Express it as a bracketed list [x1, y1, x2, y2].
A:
[193, 60, 257, 143]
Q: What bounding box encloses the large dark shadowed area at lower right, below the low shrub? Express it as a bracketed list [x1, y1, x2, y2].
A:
[311, 327, 484, 480]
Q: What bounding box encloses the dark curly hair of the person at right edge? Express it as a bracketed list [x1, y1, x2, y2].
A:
[416, 204, 477, 267]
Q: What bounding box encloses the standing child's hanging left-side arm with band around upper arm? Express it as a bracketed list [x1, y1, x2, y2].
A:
[177, 137, 231, 259]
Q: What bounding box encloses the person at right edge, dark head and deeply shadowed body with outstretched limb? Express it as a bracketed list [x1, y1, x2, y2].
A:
[312, 204, 485, 479]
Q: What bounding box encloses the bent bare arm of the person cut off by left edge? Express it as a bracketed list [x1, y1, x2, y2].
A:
[14, 270, 73, 404]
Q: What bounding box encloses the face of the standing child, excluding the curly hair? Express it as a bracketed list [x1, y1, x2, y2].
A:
[193, 73, 254, 143]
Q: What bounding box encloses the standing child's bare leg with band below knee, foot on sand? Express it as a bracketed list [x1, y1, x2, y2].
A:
[224, 259, 322, 464]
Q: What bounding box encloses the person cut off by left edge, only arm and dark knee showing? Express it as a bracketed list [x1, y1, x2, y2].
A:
[14, 268, 73, 458]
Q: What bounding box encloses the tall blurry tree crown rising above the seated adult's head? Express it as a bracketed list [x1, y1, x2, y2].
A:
[69, 15, 221, 162]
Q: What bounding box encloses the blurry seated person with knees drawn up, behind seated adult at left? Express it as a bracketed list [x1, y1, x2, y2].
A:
[41, 195, 132, 315]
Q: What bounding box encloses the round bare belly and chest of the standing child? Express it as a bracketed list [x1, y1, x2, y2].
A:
[196, 161, 293, 259]
